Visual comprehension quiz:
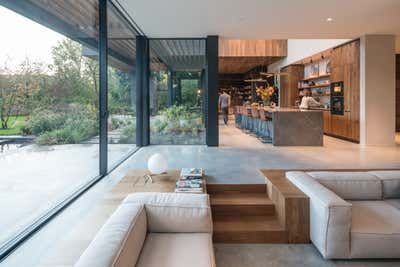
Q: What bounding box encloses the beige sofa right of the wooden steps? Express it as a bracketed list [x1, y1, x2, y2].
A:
[286, 171, 400, 259]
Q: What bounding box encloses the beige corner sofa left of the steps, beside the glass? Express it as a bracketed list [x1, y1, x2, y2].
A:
[75, 193, 215, 267]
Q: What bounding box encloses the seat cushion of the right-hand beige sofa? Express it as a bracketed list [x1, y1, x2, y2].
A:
[350, 201, 400, 258]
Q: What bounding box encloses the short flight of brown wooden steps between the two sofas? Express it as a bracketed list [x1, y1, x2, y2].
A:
[207, 184, 287, 243]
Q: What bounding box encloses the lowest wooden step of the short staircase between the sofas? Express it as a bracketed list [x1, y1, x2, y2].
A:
[213, 216, 287, 243]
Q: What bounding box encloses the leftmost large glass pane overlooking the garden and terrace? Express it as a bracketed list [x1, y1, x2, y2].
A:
[0, 0, 99, 247]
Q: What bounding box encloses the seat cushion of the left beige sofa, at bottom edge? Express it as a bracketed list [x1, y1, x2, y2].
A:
[136, 233, 215, 267]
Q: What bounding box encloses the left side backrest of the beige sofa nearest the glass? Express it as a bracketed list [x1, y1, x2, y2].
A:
[75, 203, 147, 267]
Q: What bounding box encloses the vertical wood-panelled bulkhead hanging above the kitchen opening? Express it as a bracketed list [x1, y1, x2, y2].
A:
[219, 38, 287, 57]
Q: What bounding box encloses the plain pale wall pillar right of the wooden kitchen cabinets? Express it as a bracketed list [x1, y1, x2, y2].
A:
[360, 35, 396, 145]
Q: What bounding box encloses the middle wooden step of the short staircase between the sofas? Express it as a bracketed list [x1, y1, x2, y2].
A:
[210, 193, 275, 216]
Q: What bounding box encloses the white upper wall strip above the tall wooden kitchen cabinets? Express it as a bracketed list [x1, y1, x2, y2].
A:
[268, 39, 350, 72]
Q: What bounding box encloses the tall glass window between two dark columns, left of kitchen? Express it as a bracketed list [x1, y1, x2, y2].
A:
[150, 39, 205, 144]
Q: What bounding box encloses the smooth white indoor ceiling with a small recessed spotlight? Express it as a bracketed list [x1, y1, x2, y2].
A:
[119, 0, 400, 39]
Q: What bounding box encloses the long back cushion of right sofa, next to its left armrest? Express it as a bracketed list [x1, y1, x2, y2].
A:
[307, 171, 382, 200]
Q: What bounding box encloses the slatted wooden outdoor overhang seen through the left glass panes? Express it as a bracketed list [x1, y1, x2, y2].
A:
[26, 0, 138, 69]
